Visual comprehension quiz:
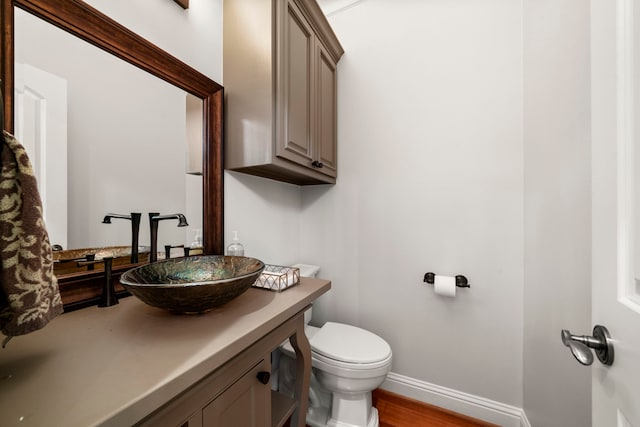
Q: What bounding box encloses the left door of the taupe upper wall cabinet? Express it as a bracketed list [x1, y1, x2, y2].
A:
[276, 0, 315, 166]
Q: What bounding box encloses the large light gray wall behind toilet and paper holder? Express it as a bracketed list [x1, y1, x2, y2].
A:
[300, 0, 523, 407]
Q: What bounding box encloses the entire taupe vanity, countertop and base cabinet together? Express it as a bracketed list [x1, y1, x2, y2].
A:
[0, 277, 331, 427]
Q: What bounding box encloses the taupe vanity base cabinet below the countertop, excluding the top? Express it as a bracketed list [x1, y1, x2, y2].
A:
[137, 304, 311, 427]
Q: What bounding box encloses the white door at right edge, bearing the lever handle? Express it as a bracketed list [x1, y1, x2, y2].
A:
[592, 0, 640, 427]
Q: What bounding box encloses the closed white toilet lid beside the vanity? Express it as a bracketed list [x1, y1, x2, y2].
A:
[309, 322, 391, 363]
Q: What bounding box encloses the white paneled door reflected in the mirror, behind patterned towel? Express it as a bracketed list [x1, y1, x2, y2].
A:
[14, 63, 67, 249]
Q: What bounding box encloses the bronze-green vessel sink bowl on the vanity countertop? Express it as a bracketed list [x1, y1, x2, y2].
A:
[120, 255, 264, 313]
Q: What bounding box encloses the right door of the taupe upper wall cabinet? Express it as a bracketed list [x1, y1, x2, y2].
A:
[314, 42, 338, 177]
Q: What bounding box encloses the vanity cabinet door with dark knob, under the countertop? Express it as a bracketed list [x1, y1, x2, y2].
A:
[202, 360, 271, 427]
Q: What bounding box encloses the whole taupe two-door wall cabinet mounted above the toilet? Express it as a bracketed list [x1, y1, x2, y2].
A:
[223, 0, 344, 185]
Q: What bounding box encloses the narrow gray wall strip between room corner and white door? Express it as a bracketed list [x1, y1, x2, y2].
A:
[523, 0, 591, 427]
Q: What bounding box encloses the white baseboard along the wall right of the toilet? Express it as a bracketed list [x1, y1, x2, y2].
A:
[380, 372, 531, 427]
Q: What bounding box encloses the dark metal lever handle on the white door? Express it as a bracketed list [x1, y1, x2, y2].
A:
[560, 325, 614, 366]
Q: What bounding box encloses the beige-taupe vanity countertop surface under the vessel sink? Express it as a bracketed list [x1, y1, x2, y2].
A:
[0, 278, 331, 427]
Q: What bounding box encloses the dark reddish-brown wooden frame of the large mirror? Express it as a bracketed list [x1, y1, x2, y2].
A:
[0, 0, 224, 310]
